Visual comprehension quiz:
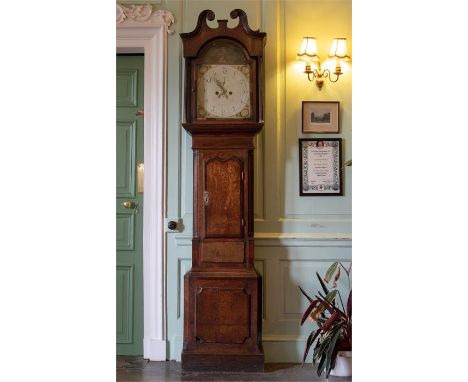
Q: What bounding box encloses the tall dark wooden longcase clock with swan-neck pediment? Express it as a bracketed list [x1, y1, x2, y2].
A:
[181, 9, 266, 371]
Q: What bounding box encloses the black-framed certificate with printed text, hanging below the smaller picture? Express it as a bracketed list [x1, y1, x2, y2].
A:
[299, 138, 343, 196]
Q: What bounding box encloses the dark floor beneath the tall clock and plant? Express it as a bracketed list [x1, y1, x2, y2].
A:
[117, 356, 351, 382]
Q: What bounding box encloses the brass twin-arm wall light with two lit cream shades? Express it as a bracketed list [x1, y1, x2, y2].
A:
[297, 37, 351, 90]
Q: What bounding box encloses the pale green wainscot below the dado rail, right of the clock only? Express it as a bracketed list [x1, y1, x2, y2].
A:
[255, 243, 351, 362]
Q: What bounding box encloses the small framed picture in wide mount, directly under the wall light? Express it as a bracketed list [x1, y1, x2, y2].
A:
[302, 101, 340, 133]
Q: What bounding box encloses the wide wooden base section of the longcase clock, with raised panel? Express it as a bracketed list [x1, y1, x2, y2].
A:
[182, 270, 265, 371]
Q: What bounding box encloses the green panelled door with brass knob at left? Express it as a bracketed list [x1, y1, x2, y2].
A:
[116, 56, 144, 355]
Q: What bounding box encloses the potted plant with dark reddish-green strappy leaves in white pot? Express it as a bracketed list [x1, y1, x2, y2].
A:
[299, 262, 352, 378]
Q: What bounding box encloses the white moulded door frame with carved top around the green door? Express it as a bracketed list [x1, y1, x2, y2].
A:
[116, 4, 174, 361]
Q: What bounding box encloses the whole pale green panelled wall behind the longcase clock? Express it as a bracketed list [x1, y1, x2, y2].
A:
[161, 0, 352, 362]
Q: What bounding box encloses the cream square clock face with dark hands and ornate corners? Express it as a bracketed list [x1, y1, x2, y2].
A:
[197, 65, 251, 119]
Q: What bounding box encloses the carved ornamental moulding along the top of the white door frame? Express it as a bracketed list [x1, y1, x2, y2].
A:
[115, 4, 175, 34]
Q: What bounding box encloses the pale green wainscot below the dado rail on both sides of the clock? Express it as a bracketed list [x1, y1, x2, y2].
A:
[168, 233, 351, 362]
